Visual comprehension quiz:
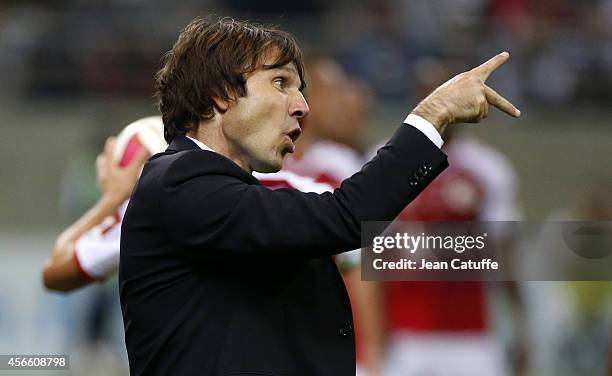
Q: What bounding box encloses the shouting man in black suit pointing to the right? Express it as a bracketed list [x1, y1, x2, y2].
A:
[119, 18, 519, 376]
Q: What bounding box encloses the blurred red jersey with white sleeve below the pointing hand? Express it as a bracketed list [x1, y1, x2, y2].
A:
[384, 136, 519, 332]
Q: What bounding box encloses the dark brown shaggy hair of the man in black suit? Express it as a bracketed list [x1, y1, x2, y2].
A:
[155, 17, 305, 142]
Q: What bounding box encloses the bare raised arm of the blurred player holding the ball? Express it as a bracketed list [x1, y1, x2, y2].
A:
[43, 138, 149, 291]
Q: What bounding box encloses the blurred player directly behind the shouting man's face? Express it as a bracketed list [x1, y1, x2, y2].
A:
[284, 54, 369, 185]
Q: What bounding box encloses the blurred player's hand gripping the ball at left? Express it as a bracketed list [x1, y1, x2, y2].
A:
[96, 137, 149, 203]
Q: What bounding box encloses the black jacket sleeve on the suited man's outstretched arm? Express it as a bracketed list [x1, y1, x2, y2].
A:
[160, 125, 448, 257]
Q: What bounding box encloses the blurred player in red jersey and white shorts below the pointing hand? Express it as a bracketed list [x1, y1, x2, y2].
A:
[372, 60, 524, 376]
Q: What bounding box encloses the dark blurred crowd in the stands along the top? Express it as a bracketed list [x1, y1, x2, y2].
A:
[0, 0, 612, 106]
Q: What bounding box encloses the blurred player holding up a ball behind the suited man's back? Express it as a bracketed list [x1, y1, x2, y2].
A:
[43, 116, 167, 291]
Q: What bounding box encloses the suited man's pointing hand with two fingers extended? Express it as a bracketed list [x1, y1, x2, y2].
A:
[412, 52, 521, 133]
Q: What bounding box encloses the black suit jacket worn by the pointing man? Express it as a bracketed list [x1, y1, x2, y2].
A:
[119, 125, 448, 376]
